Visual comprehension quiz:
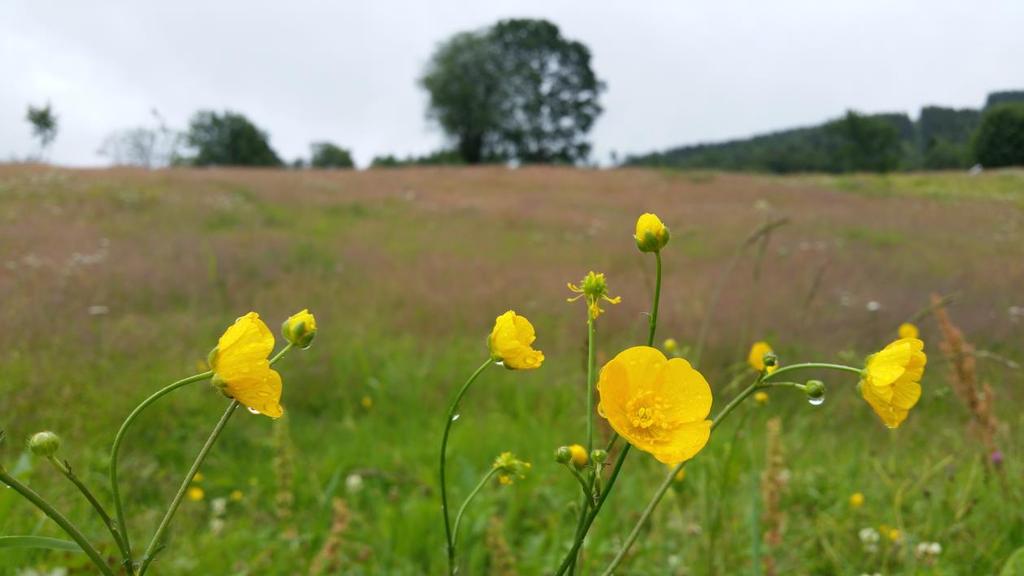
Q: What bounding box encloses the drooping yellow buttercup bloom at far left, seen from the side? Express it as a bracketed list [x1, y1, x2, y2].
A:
[210, 312, 285, 418]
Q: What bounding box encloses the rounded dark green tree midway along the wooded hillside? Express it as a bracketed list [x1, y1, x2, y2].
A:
[825, 111, 903, 172]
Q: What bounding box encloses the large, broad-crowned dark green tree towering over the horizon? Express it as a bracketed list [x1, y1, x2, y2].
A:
[420, 19, 604, 164]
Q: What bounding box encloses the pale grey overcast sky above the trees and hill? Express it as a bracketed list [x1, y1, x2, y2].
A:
[0, 0, 1024, 165]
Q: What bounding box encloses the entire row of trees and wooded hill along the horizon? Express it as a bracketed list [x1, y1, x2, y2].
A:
[19, 18, 1024, 173]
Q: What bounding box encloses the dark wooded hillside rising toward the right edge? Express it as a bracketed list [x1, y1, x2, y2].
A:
[625, 91, 1024, 173]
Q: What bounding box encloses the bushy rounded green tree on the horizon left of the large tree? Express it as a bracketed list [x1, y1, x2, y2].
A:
[185, 111, 282, 166]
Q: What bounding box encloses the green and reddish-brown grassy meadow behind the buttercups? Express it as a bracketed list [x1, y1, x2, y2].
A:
[0, 166, 1024, 575]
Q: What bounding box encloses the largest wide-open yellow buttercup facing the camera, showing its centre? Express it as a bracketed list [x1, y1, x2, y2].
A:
[597, 346, 712, 463]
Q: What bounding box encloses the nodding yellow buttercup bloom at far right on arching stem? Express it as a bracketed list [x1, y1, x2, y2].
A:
[859, 338, 928, 428]
